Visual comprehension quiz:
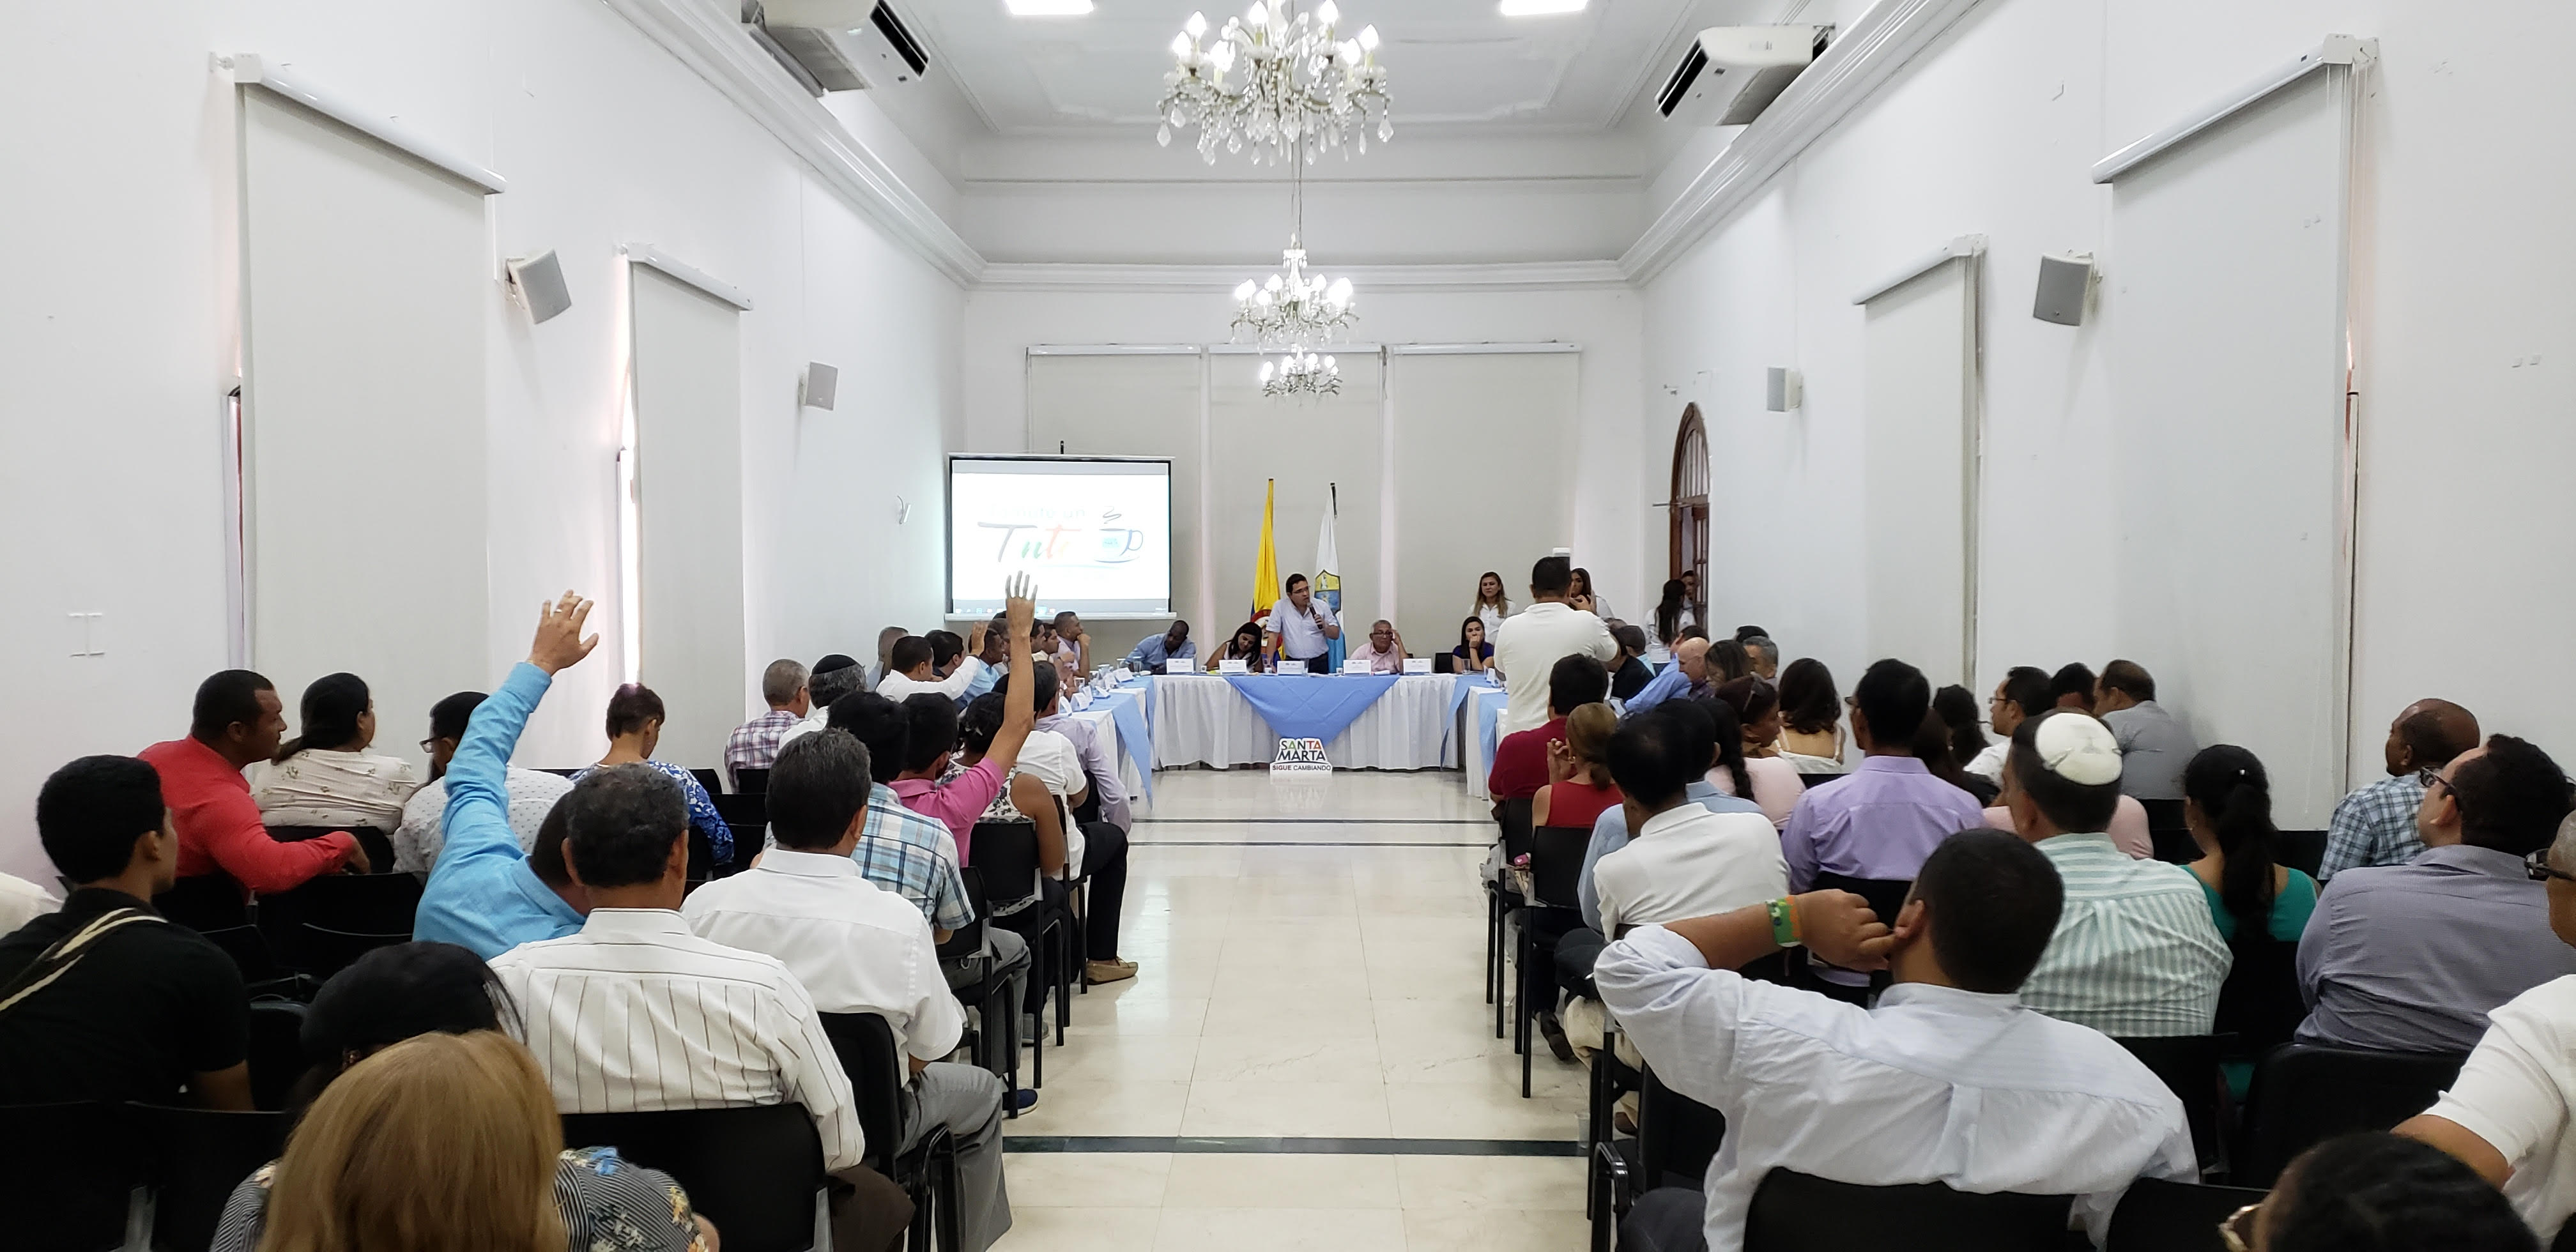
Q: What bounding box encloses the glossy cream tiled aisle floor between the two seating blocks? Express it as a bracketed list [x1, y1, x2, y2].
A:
[999, 770, 1584, 1252]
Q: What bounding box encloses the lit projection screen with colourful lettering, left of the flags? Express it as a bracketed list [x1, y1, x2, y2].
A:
[948, 456, 1172, 618]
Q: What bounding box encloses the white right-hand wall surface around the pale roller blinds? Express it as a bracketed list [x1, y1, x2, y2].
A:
[1643, 0, 2576, 804]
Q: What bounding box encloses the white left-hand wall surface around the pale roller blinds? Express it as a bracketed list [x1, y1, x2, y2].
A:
[0, 0, 961, 881]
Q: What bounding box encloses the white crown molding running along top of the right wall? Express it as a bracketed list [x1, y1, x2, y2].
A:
[1618, 0, 1979, 284]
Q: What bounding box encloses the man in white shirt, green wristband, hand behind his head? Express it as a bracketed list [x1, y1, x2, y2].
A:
[1595, 830, 2197, 1252]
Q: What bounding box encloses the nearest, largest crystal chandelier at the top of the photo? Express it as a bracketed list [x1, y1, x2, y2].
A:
[1154, 0, 1396, 165]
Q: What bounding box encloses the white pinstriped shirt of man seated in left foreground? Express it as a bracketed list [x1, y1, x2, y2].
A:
[492, 910, 868, 1170]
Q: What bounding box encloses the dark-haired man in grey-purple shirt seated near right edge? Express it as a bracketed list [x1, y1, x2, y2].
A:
[2298, 734, 2576, 1051]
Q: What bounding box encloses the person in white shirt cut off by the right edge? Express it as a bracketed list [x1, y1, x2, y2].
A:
[2390, 814, 2576, 1239]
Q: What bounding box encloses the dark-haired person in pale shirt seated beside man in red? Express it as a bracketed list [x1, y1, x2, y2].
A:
[250, 675, 420, 835]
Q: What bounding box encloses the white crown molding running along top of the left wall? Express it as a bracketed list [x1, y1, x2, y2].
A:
[606, 0, 984, 286]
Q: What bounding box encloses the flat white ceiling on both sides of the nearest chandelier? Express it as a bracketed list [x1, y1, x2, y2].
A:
[894, 0, 1708, 137]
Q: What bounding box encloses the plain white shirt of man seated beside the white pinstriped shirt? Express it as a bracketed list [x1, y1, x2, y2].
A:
[680, 848, 966, 1062]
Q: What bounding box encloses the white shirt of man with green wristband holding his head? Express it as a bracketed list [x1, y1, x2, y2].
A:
[1592, 922, 2200, 1252]
